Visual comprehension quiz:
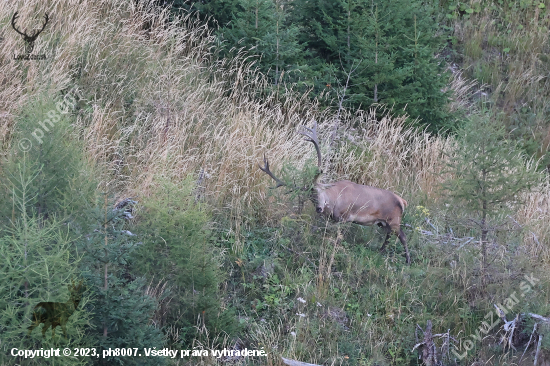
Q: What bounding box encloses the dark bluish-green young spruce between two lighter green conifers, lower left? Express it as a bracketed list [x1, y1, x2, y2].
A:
[77, 195, 165, 365]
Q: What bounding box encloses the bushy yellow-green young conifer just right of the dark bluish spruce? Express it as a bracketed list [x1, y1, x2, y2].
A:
[132, 178, 239, 344]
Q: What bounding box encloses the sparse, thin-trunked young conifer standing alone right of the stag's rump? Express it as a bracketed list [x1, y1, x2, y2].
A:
[443, 115, 540, 269]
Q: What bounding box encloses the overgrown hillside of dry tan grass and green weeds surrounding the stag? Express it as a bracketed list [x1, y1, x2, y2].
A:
[0, 0, 550, 365]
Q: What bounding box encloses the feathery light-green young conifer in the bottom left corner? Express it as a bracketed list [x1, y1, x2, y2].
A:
[0, 154, 92, 365]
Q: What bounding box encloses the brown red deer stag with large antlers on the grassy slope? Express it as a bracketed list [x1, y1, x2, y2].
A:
[260, 123, 411, 264]
